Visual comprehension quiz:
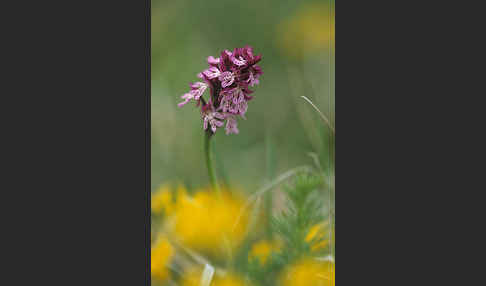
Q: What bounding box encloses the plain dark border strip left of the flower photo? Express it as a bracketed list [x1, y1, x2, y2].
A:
[0, 0, 151, 286]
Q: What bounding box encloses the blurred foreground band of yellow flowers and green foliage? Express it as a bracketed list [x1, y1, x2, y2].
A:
[152, 173, 334, 286]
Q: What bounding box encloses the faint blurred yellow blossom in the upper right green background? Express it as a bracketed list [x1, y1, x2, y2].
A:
[277, 3, 334, 58]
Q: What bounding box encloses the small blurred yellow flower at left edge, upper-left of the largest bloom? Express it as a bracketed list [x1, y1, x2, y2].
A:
[152, 184, 186, 215]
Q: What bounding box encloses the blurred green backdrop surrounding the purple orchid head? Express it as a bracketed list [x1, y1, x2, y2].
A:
[151, 0, 334, 192]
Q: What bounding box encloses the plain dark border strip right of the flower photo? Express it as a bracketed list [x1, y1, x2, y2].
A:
[336, 1, 486, 285]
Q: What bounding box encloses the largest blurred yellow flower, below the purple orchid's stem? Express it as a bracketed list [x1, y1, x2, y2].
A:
[173, 189, 248, 255]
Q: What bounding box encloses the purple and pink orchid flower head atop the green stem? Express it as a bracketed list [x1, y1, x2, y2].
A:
[178, 46, 263, 134]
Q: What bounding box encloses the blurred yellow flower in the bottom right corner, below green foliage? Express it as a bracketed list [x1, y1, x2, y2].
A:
[281, 258, 336, 286]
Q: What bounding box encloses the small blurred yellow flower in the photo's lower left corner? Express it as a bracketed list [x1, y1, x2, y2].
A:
[150, 237, 174, 280]
